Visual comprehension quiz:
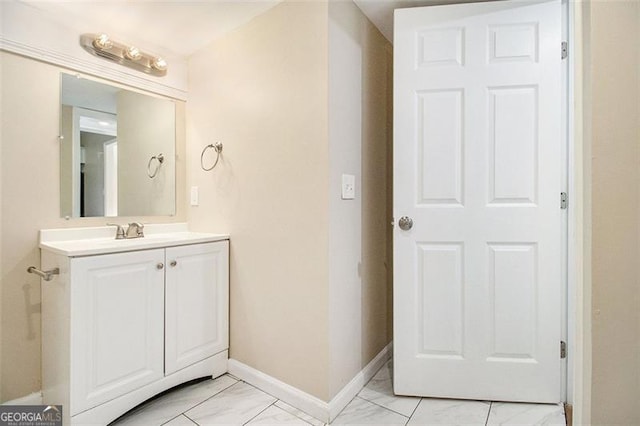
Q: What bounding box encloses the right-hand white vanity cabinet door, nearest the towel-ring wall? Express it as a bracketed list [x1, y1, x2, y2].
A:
[165, 241, 229, 375]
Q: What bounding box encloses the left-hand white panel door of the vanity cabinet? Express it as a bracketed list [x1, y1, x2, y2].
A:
[70, 249, 165, 415]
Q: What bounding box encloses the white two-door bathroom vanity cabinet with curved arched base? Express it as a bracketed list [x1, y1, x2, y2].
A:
[40, 228, 229, 424]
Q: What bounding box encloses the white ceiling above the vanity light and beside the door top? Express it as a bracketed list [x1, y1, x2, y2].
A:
[18, 0, 477, 57]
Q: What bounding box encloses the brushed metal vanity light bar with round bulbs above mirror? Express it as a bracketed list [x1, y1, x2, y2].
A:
[80, 33, 167, 77]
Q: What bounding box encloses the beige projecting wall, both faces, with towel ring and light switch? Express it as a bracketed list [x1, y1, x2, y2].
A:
[187, 1, 391, 401]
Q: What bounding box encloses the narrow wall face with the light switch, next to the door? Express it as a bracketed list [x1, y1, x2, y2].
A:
[328, 1, 391, 397]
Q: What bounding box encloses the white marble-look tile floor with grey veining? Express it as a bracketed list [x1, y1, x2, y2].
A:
[111, 361, 565, 426]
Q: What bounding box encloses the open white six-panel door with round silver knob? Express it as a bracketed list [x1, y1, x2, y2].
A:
[394, 0, 564, 402]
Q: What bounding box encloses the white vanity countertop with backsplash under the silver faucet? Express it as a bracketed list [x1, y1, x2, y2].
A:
[40, 223, 229, 257]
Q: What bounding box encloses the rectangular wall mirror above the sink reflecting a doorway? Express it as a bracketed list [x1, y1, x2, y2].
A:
[60, 74, 175, 217]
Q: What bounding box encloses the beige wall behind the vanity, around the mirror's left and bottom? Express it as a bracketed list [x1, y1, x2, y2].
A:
[0, 52, 186, 401]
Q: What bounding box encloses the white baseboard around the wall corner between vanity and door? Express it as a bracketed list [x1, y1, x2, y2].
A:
[228, 343, 393, 423]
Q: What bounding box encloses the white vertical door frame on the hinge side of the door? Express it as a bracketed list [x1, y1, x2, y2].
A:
[562, 0, 591, 424]
